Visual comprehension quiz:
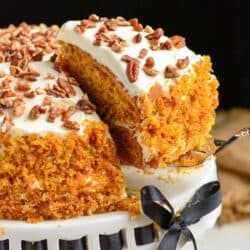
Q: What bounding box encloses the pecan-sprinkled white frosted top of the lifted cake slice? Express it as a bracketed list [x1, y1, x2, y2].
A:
[57, 15, 200, 96]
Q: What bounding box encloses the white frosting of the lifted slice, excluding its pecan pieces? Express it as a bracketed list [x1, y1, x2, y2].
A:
[57, 21, 201, 96]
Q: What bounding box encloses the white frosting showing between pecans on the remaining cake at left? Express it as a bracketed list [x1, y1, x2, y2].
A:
[0, 61, 99, 135]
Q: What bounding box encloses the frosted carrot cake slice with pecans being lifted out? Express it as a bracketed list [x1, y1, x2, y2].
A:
[56, 15, 218, 168]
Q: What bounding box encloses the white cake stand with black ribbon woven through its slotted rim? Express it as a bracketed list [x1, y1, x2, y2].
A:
[0, 159, 221, 250]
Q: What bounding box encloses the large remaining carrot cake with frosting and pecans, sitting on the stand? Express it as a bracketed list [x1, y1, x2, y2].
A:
[0, 24, 126, 222]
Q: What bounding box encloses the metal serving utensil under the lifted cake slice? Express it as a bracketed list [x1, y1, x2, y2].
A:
[172, 128, 250, 168]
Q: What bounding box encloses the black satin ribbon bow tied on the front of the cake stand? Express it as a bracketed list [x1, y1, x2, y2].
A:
[141, 181, 222, 250]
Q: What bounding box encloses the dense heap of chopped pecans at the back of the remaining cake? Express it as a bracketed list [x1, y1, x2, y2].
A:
[0, 23, 58, 65]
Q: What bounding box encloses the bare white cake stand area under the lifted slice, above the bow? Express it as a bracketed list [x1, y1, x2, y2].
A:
[122, 158, 217, 211]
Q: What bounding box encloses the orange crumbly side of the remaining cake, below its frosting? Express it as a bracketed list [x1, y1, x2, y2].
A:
[0, 122, 125, 222]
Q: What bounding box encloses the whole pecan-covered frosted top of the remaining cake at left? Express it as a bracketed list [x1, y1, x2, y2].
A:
[0, 23, 99, 137]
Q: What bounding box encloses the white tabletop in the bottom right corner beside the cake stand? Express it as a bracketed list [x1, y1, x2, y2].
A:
[199, 220, 250, 250]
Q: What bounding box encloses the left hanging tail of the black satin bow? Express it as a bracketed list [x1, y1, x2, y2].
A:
[158, 228, 181, 250]
